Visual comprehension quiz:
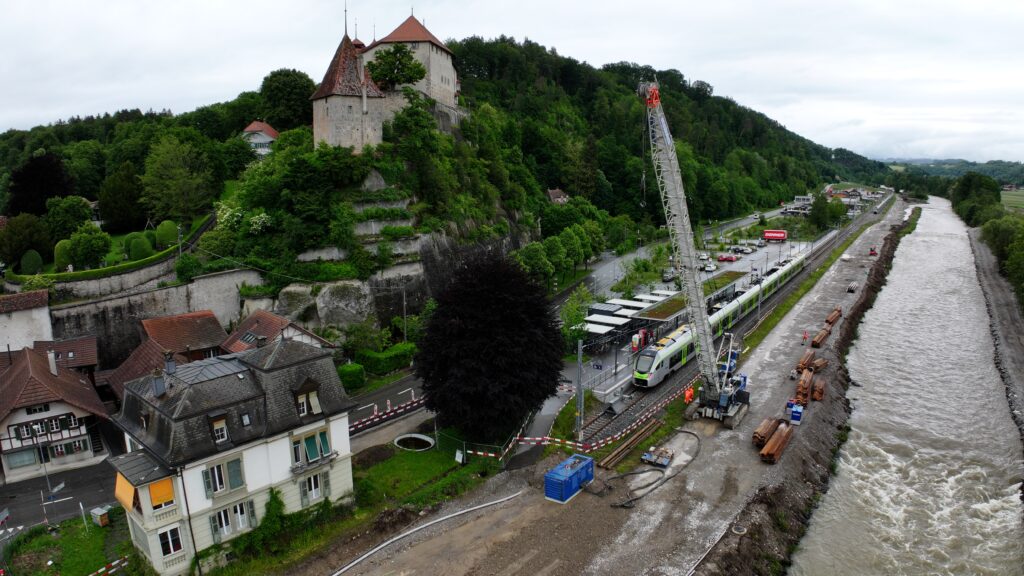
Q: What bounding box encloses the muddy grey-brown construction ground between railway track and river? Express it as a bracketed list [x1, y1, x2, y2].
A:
[290, 199, 903, 576]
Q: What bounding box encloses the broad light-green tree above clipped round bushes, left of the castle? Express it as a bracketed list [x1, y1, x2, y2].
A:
[142, 135, 213, 221]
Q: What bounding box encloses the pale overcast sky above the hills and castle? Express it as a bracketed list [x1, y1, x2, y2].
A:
[0, 0, 1024, 161]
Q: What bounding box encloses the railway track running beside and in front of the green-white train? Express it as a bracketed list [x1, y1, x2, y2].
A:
[583, 214, 869, 444]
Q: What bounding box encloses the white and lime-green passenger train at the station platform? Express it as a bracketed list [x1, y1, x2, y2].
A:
[633, 254, 807, 388]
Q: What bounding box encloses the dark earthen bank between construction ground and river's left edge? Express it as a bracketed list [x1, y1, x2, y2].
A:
[695, 204, 915, 575]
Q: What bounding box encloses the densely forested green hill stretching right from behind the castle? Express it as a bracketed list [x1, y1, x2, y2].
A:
[449, 37, 887, 221]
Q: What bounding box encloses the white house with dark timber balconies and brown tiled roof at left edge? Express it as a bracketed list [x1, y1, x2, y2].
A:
[0, 347, 108, 483]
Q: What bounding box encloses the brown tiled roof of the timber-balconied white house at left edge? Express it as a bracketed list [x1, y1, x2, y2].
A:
[0, 347, 106, 420]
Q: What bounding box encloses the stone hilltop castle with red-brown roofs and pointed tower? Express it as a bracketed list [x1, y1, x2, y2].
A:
[310, 15, 459, 152]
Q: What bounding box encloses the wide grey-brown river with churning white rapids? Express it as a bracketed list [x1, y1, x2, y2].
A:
[790, 198, 1024, 576]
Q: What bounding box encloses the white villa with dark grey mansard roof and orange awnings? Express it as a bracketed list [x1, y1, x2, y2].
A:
[110, 339, 353, 574]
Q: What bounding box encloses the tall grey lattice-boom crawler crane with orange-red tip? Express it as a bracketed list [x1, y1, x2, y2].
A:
[638, 82, 750, 428]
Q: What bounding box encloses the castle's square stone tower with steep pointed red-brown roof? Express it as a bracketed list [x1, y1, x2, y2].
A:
[310, 33, 384, 153]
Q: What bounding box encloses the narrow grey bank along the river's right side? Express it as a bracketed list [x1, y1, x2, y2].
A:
[968, 228, 1024, 501]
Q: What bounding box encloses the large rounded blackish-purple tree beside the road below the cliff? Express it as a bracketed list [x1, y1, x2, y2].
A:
[416, 253, 562, 441]
